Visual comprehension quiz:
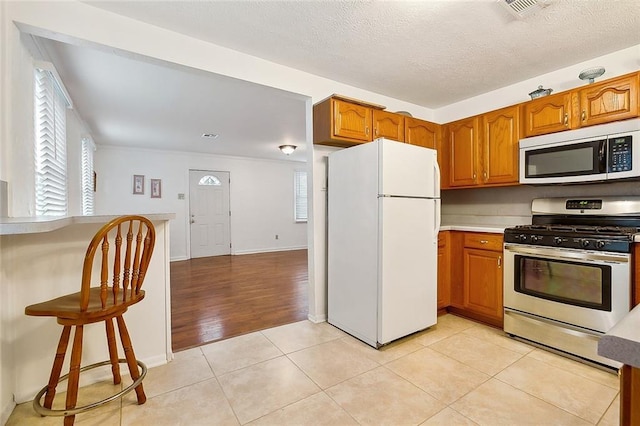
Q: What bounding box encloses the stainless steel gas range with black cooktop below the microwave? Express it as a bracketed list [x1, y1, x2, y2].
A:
[504, 197, 640, 369]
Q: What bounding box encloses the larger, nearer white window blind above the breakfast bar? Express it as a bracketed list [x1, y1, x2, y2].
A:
[35, 68, 70, 216]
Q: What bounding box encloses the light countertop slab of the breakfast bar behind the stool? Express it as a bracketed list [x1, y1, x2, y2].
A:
[0, 213, 176, 235]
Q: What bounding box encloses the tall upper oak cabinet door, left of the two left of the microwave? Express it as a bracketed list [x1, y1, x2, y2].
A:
[447, 117, 478, 186]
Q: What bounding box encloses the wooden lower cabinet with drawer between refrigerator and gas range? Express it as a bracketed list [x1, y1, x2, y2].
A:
[449, 231, 503, 327]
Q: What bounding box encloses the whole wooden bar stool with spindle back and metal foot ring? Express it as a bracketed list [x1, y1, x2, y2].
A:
[24, 216, 156, 425]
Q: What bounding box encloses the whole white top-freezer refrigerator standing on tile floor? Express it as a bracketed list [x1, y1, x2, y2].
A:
[327, 139, 440, 348]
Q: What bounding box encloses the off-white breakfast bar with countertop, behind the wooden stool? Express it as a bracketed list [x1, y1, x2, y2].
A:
[0, 213, 175, 403]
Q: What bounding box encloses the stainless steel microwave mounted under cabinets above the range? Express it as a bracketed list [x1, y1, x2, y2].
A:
[520, 119, 640, 184]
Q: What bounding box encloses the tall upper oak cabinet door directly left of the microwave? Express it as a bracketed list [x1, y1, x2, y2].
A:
[482, 106, 520, 184]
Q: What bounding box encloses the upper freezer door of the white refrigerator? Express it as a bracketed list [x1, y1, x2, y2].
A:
[376, 139, 440, 198]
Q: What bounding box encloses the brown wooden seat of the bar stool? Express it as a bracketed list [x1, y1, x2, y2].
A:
[24, 287, 144, 324]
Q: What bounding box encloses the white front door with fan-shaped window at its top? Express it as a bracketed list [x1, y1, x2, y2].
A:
[189, 170, 231, 258]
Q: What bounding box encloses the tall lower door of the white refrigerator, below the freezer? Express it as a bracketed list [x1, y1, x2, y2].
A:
[378, 197, 440, 344]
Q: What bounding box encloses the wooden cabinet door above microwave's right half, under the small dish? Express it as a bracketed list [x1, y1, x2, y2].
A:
[578, 74, 638, 126]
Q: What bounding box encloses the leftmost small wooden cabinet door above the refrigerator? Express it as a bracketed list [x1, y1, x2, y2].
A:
[331, 99, 372, 142]
